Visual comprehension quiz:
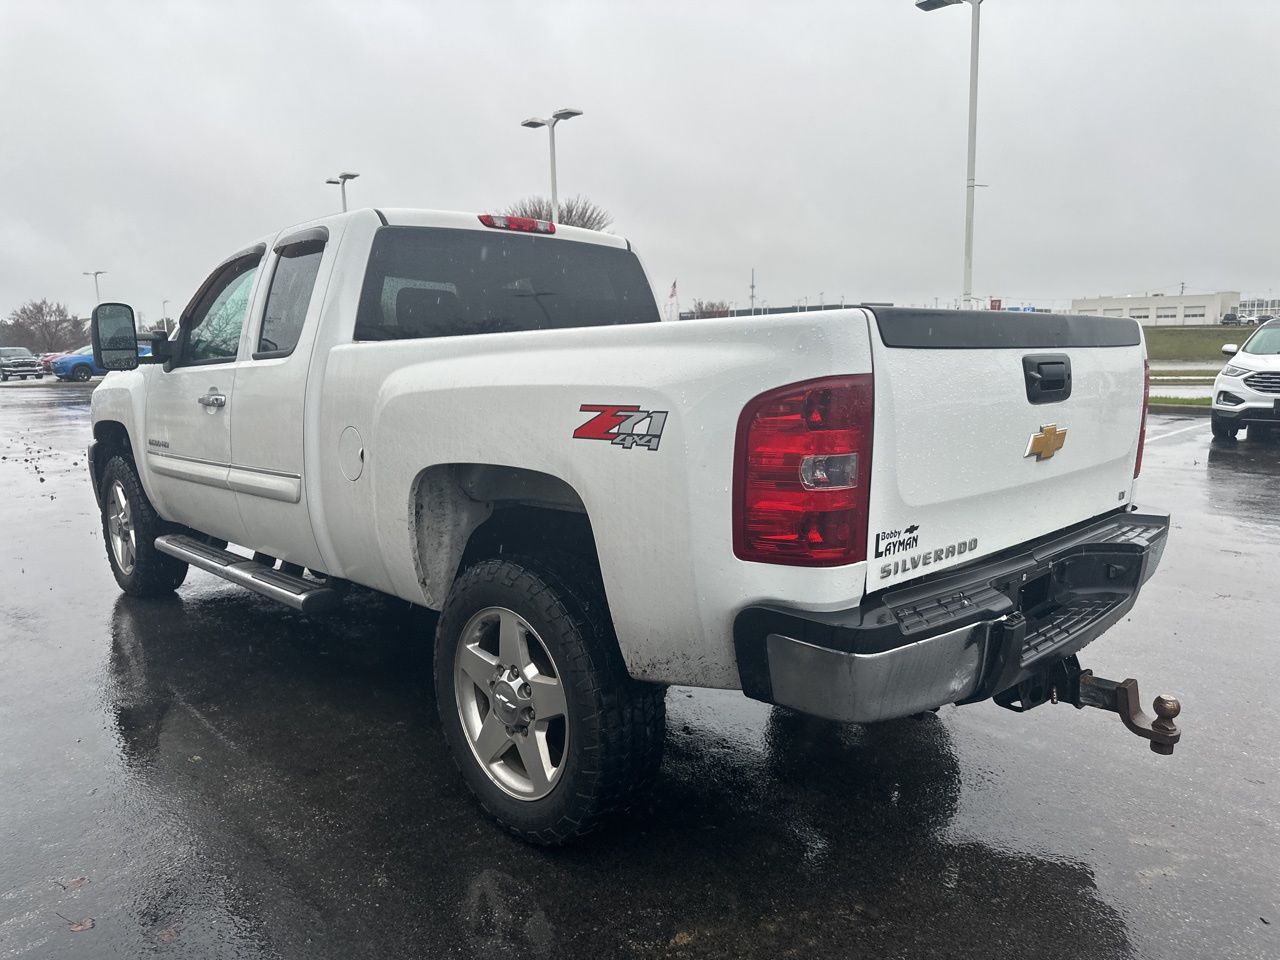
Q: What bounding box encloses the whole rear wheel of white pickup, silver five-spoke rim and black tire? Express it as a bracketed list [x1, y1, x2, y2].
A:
[435, 557, 666, 845]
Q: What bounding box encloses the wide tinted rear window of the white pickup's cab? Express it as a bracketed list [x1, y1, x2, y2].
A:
[355, 227, 660, 340]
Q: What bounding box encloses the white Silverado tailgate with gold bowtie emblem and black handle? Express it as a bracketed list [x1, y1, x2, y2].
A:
[867, 307, 1146, 593]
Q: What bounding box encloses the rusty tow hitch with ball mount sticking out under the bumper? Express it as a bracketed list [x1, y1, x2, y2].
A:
[995, 657, 1183, 756]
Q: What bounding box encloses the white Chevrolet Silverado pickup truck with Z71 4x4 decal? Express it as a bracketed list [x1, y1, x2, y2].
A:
[88, 210, 1179, 842]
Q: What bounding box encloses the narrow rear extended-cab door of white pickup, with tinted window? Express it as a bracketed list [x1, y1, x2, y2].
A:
[230, 227, 337, 570]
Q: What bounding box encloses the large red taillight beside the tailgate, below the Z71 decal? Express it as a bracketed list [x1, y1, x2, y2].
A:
[733, 374, 873, 567]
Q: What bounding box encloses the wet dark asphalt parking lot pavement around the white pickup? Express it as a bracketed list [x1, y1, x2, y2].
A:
[0, 384, 1280, 960]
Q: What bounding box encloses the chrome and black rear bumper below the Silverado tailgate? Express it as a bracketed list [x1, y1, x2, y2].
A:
[733, 512, 1169, 723]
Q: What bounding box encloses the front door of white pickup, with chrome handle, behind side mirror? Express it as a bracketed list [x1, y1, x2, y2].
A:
[142, 244, 266, 543]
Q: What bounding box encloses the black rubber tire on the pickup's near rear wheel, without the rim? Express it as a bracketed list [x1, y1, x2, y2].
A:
[435, 557, 667, 846]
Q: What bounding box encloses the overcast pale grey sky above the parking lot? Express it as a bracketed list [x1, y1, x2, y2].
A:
[0, 0, 1280, 320]
